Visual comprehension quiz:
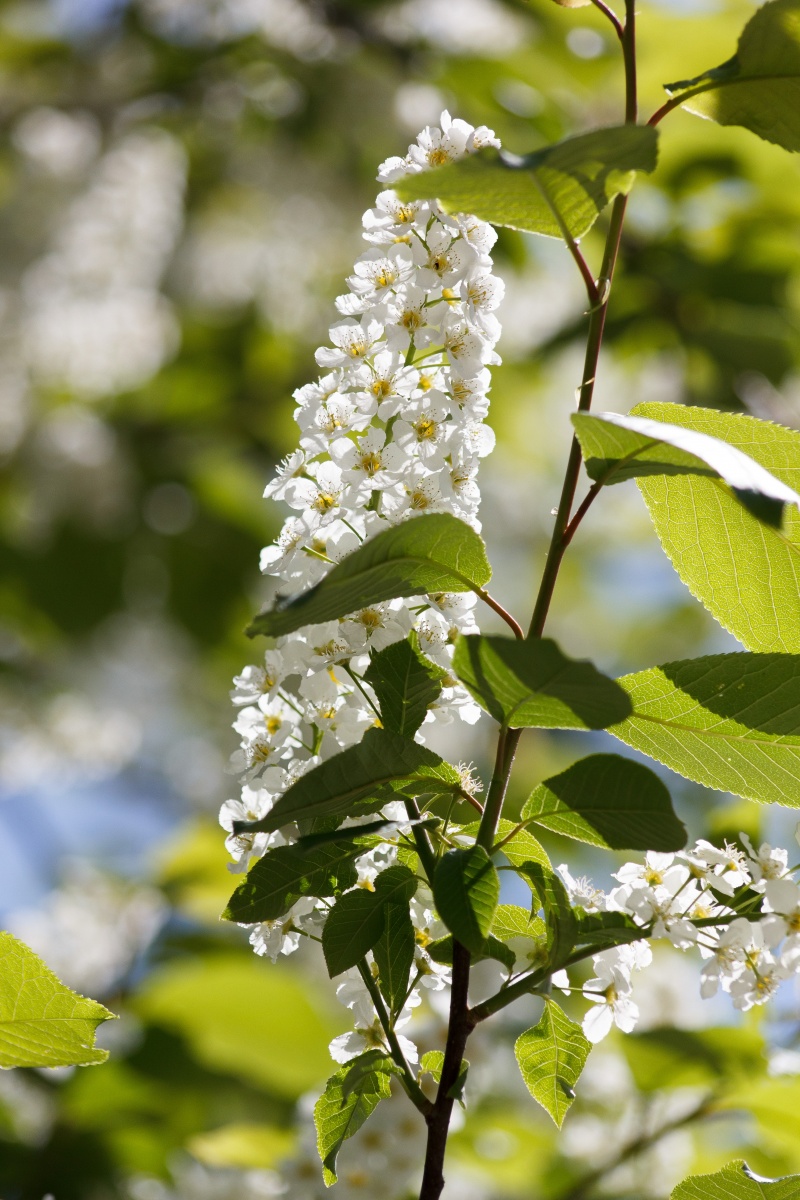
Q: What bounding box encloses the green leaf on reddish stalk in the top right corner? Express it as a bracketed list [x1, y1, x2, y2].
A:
[664, 0, 800, 150]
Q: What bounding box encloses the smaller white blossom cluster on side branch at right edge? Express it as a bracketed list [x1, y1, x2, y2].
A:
[553, 826, 800, 1042]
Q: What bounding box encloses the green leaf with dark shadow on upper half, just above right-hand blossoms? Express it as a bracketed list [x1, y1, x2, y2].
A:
[609, 654, 800, 808]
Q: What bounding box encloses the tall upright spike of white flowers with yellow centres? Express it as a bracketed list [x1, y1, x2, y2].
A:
[221, 112, 503, 1062]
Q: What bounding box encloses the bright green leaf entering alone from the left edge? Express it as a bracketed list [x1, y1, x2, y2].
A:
[0, 931, 114, 1068]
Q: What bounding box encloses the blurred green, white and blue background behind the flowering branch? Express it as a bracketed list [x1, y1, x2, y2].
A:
[0, 0, 800, 1200]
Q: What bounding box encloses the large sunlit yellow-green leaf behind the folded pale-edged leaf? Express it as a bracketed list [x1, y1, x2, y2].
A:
[633, 404, 800, 654]
